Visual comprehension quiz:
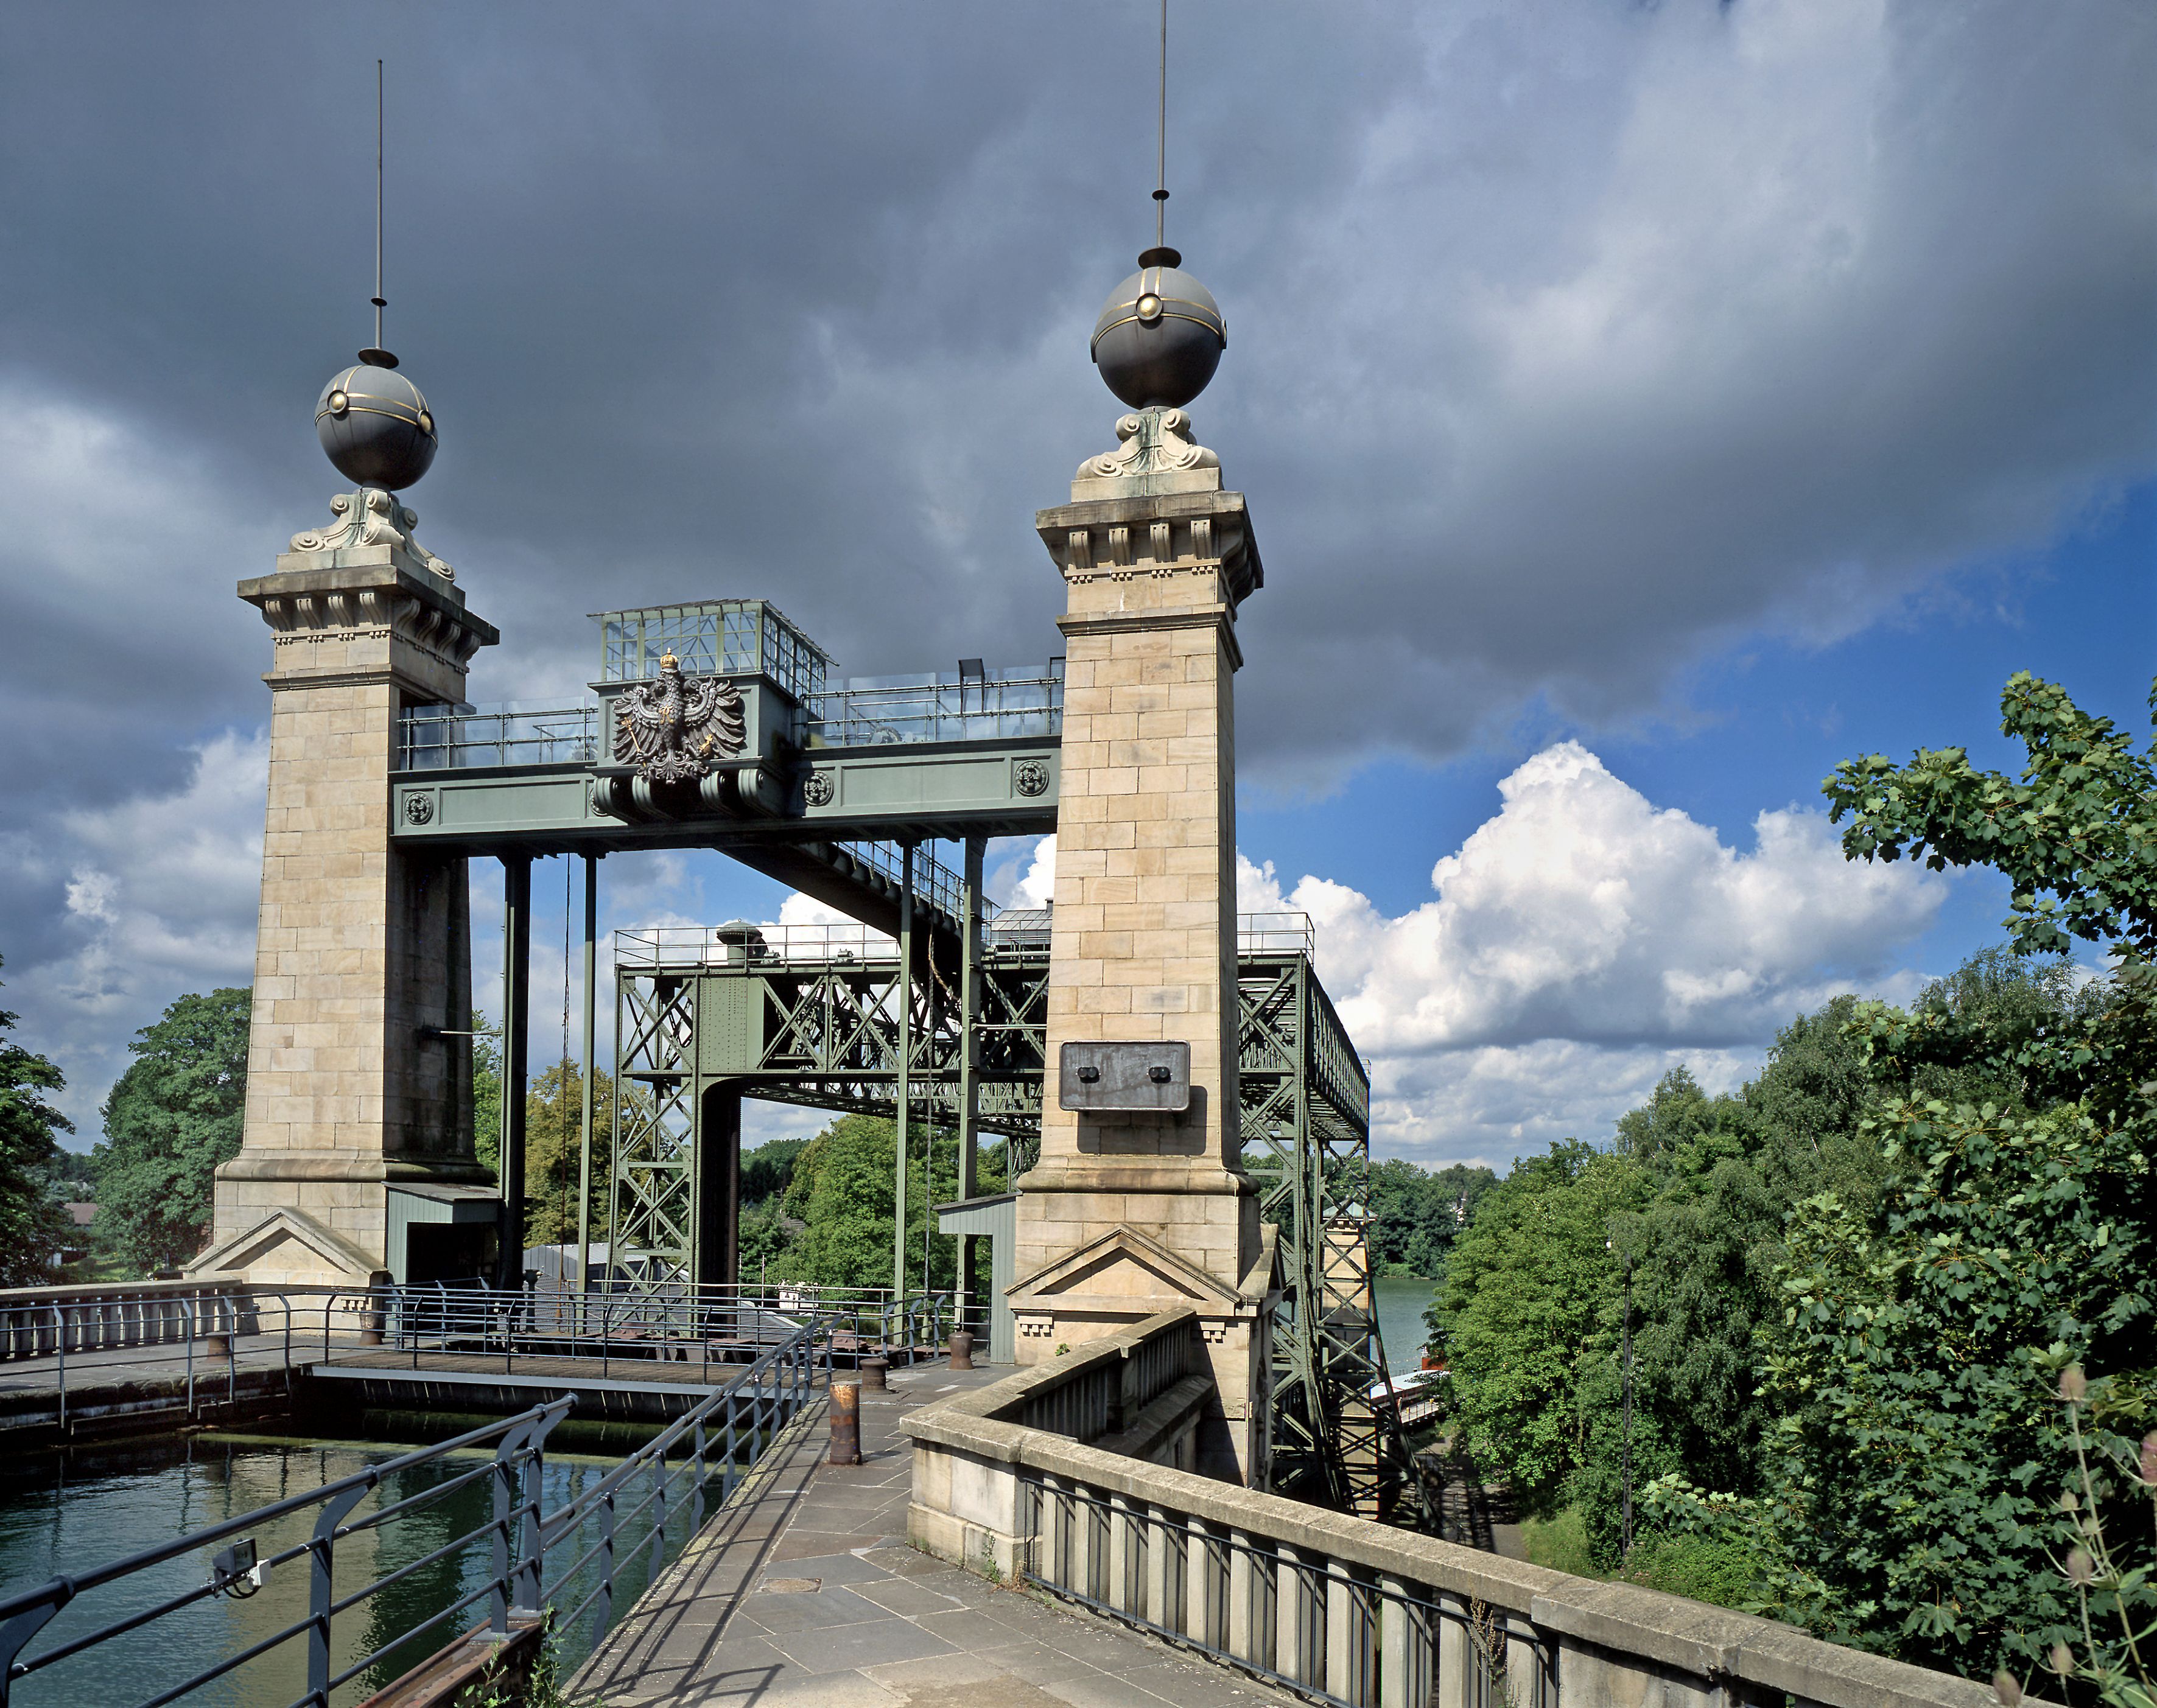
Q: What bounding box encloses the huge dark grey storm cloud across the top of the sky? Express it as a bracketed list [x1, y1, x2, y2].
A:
[0, 0, 2157, 1130]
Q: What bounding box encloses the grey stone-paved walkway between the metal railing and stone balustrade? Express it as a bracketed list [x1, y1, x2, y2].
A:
[569, 1367, 1292, 1708]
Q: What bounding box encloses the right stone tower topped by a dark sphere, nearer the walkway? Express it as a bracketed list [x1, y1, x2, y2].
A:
[1009, 273, 1277, 1482]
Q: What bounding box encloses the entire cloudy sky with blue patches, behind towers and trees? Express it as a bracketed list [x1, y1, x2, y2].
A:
[0, 0, 2157, 1164]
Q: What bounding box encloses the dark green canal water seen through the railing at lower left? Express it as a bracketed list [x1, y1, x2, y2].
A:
[0, 1434, 718, 1708]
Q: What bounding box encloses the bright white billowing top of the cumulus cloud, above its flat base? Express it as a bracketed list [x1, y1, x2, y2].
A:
[1240, 742, 1946, 1052]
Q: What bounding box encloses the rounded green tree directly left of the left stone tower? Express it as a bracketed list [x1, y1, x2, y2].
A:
[93, 988, 253, 1275]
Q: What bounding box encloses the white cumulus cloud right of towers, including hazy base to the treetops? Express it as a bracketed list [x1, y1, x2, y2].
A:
[1238, 742, 1948, 1160]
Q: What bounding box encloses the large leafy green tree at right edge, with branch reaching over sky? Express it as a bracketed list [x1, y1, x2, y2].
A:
[1734, 675, 2157, 1673]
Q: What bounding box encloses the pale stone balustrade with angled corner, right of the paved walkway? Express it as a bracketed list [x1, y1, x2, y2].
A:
[906, 1311, 1993, 1708]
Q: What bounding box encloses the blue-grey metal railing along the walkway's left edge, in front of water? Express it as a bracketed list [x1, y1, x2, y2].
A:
[0, 1322, 830, 1708]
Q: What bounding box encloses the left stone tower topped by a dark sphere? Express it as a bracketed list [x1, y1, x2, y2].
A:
[190, 351, 498, 1283]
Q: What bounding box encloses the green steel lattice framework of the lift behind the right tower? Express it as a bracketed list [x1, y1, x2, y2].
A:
[615, 942, 1426, 1527]
